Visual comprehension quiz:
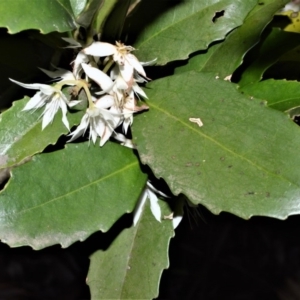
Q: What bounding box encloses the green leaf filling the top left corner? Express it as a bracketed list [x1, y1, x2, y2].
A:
[0, 0, 76, 34]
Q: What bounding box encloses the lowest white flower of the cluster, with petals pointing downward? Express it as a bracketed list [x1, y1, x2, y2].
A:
[69, 99, 122, 147]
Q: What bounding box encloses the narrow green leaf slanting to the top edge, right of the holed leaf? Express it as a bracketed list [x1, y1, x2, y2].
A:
[176, 0, 289, 78]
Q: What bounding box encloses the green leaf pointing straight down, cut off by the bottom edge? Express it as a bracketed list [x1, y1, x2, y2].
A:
[88, 201, 174, 300]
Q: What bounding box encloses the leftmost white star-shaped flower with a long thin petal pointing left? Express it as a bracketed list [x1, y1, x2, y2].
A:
[10, 79, 80, 130]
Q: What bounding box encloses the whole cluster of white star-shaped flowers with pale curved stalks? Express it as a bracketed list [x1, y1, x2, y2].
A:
[11, 42, 154, 146]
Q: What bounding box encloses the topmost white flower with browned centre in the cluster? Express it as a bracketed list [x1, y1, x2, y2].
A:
[82, 42, 146, 83]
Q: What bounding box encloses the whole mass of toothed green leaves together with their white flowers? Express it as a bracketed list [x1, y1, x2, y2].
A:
[0, 0, 300, 299]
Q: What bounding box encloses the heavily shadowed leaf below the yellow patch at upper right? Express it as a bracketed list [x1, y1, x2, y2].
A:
[239, 28, 300, 86]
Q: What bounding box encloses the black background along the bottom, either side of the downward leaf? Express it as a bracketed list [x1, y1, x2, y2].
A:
[0, 207, 300, 300]
